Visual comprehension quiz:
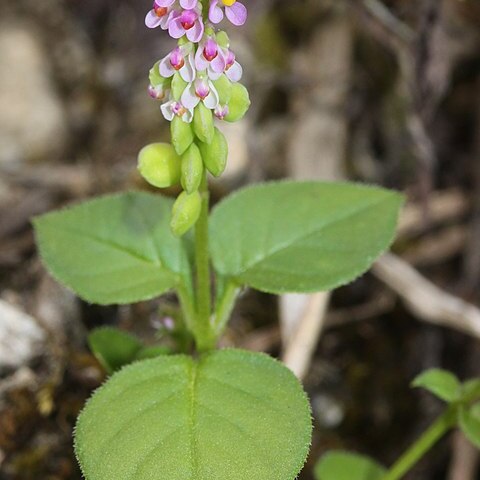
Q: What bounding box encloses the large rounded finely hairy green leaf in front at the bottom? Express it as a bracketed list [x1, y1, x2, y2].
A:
[75, 350, 311, 480]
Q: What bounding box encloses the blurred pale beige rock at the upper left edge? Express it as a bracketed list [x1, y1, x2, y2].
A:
[0, 23, 66, 164]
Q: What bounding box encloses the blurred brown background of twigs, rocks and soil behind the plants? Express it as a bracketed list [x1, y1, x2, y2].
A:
[0, 0, 480, 480]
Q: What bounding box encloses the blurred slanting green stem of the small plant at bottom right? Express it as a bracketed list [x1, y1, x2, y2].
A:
[382, 405, 457, 480]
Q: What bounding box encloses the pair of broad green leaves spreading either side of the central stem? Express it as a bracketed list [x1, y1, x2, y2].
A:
[34, 182, 401, 304]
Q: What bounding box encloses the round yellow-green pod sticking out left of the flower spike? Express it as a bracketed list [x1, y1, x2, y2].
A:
[138, 143, 181, 188]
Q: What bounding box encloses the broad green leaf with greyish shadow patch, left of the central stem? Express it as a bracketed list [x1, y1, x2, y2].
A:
[34, 192, 190, 305]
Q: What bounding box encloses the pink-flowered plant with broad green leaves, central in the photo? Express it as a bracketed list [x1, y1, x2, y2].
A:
[34, 0, 402, 480]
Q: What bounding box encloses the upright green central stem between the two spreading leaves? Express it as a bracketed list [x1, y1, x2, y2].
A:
[194, 173, 215, 351]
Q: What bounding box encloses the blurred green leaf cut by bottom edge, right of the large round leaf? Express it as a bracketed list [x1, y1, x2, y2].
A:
[315, 451, 387, 480]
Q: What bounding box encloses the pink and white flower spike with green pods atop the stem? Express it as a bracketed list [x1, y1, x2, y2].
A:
[140, 0, 250, 235]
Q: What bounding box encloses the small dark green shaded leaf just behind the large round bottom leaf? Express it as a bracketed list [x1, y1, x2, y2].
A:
[88, 327, 143, 374]
